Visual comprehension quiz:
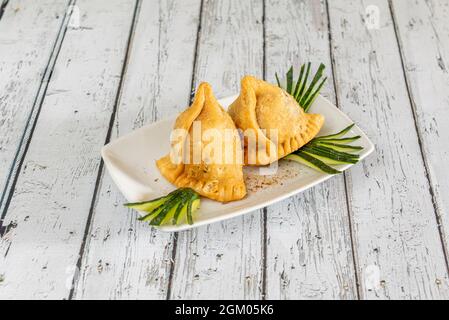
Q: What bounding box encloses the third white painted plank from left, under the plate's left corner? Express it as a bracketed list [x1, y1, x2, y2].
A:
[74, 0, 200, 299]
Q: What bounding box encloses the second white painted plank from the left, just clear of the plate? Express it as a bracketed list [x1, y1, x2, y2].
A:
[0, 0, 135, 299]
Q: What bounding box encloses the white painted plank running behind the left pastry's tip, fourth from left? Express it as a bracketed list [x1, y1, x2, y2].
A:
[170, 0, 263, 299]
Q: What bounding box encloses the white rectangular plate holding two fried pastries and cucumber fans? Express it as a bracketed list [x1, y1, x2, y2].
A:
[101, 96, 374, 231]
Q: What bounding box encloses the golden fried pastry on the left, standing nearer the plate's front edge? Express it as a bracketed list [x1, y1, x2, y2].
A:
[156, 83, 246, 202]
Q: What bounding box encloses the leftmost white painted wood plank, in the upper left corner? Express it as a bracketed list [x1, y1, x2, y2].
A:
[0, 0, 69, 214]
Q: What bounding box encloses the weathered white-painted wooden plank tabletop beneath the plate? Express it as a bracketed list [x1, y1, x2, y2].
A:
[0, 0, 449, 299]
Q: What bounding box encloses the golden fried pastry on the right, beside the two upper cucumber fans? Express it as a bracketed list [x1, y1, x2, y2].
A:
[229, 76, 324, 165]
